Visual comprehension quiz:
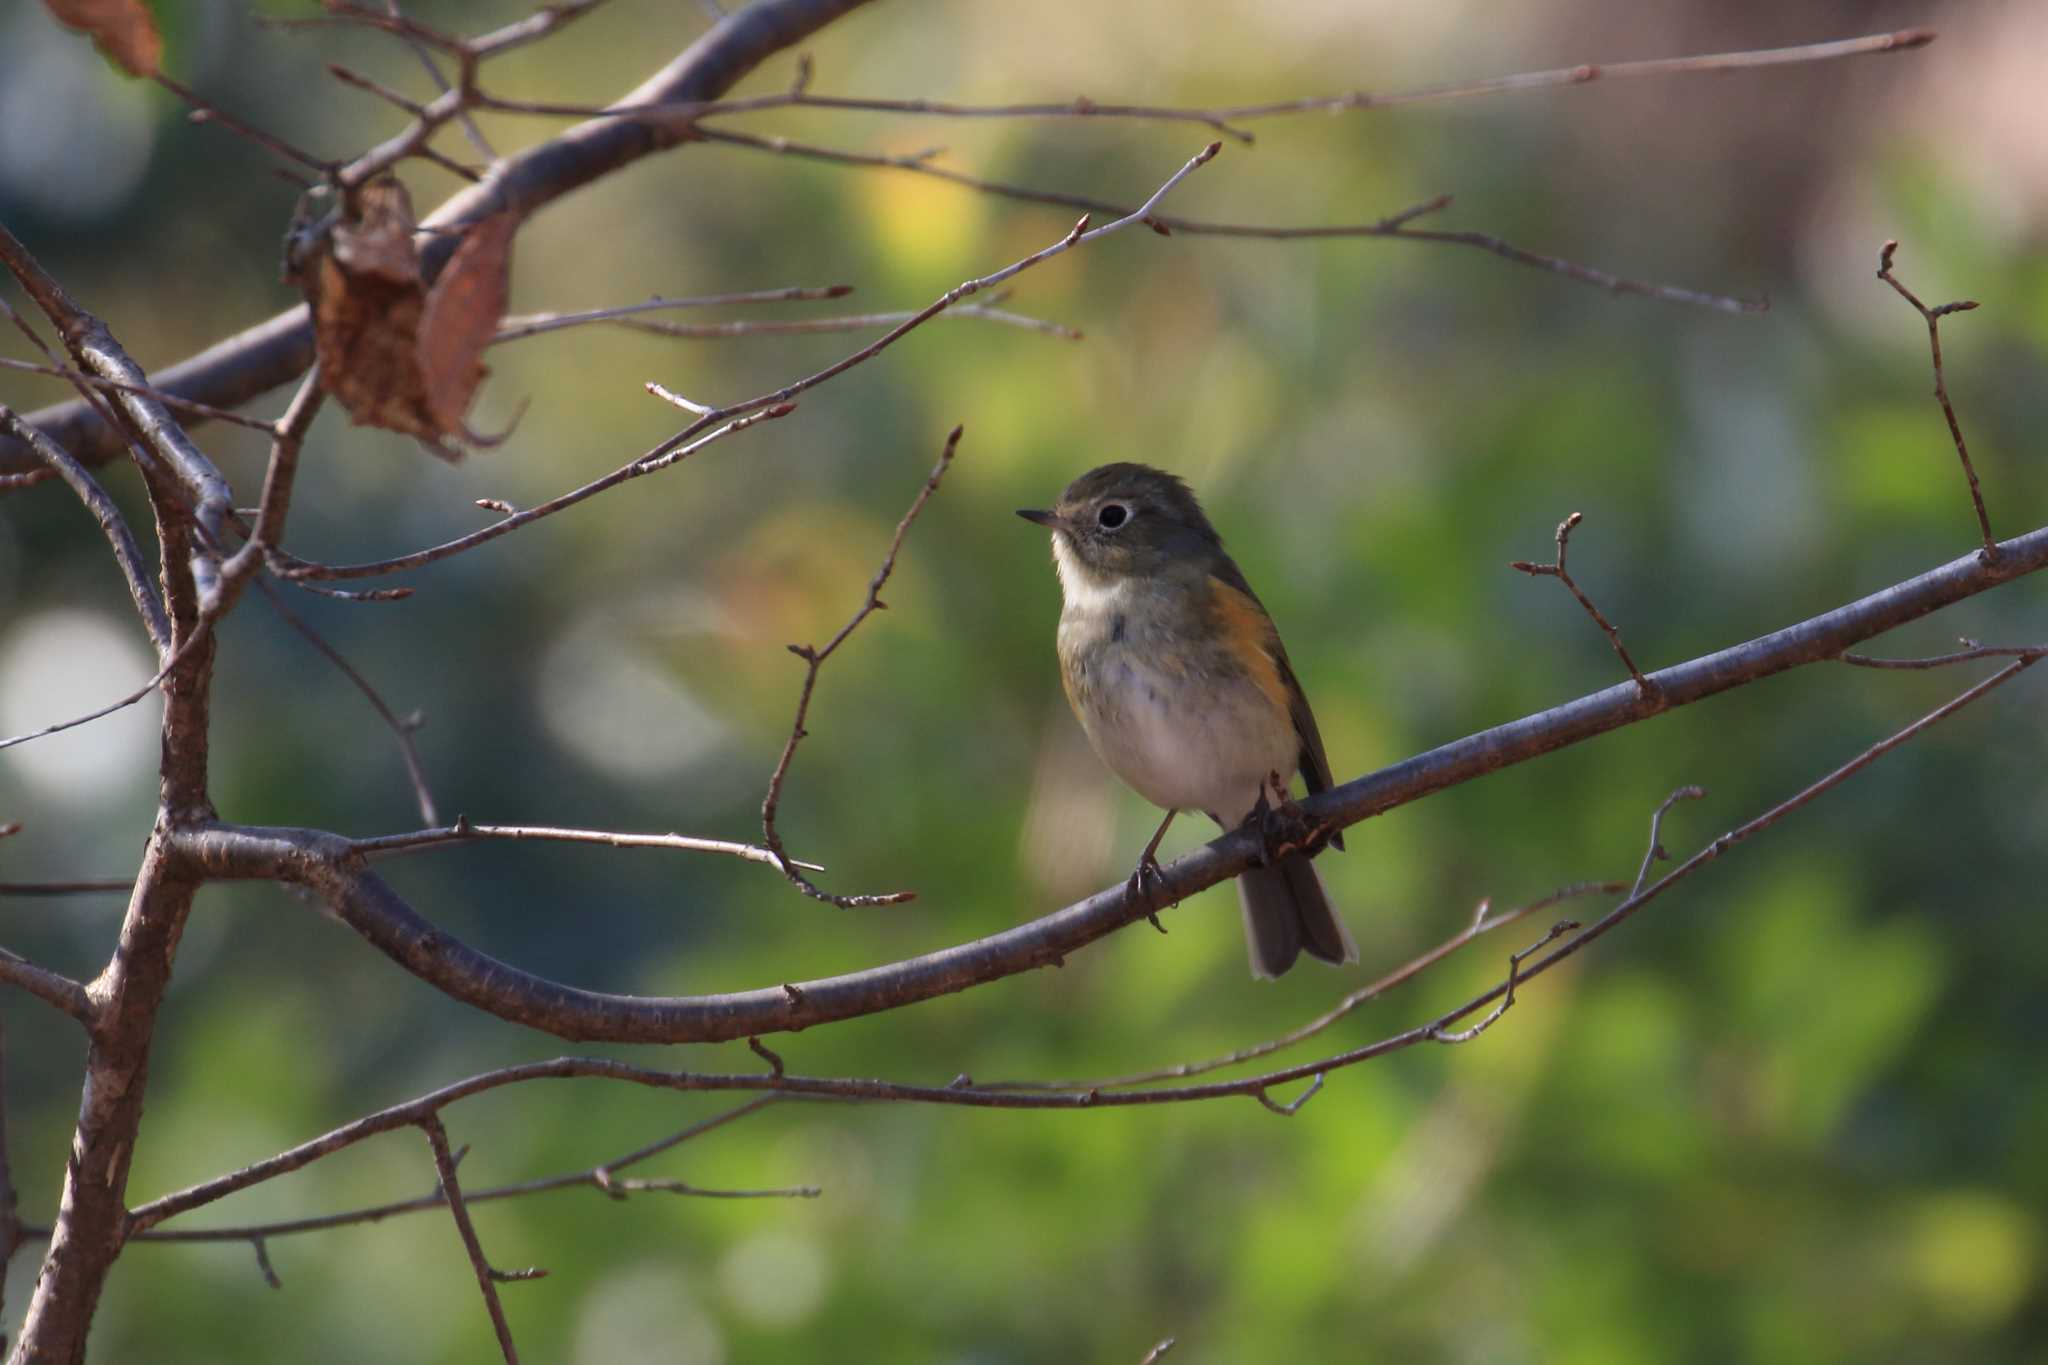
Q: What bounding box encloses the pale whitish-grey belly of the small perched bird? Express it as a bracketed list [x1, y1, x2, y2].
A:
[1071, 647, 1300, 825]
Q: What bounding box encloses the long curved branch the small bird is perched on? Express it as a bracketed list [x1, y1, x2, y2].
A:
[174, 528, 2048, 1047]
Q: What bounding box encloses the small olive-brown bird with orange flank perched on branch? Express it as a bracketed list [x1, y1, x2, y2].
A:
[1018, 463, 1358, 980]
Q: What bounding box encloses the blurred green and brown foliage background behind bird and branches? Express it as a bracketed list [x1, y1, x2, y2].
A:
[0, 0, 2048, 1365]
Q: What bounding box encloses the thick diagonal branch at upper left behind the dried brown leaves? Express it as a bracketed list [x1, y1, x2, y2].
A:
[0, 0, 866, 473]
